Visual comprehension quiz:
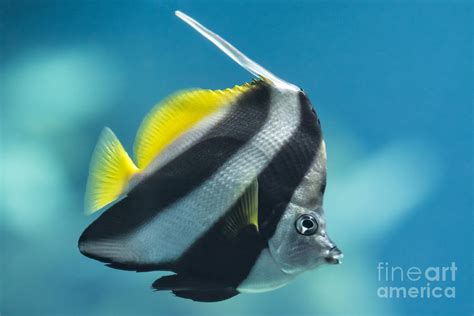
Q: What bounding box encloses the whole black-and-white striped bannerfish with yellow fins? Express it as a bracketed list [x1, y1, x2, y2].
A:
[78, 11, 342, 302]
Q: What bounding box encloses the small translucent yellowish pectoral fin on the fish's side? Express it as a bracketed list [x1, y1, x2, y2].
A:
[222, 179, 258, 237]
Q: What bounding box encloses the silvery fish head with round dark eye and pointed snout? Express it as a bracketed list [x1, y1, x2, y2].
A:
[269, 203, 343, 274]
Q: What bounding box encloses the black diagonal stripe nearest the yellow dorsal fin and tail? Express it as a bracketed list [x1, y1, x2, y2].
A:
[79, 81, 272, 270]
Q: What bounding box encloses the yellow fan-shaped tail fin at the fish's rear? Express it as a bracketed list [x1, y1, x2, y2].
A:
[84, 127, 139, 214]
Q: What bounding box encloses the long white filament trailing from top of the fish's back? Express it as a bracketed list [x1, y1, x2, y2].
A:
[175, 11, 299, 91]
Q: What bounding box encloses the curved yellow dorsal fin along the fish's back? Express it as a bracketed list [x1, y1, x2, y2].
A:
[134, 83, 252, 169]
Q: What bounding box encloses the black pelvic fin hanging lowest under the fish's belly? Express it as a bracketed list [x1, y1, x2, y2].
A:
[152, 274, 239, 302]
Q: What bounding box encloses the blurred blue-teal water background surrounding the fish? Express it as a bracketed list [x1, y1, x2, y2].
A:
[0, 0, 474, 315]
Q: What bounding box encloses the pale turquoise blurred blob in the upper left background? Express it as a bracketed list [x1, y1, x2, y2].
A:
[2, 48, 121, 132]
